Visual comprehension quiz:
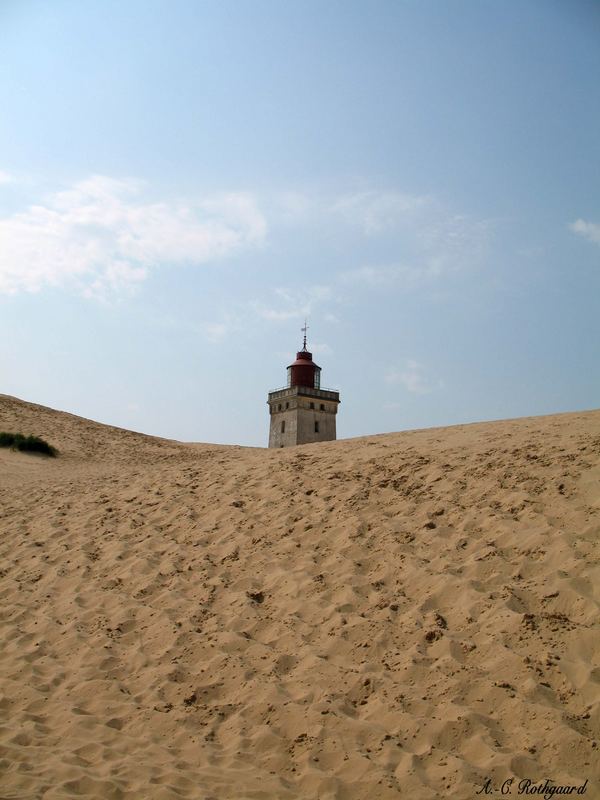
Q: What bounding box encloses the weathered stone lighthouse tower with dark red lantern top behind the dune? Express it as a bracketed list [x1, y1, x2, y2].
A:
[267, 323, 340, 447]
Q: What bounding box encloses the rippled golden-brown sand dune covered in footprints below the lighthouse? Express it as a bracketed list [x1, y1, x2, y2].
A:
[0, 396, 600, 800]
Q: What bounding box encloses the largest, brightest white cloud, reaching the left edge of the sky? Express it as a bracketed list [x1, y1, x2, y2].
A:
[0, 176, 267, 297]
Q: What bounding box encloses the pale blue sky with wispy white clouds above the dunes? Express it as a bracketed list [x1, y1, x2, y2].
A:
[0, 0, 600, 447]
